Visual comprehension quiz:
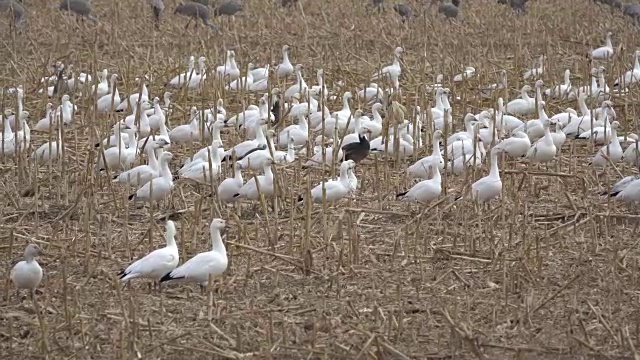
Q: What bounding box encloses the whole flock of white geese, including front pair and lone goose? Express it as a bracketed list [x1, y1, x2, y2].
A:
[5, 29, 640, 298]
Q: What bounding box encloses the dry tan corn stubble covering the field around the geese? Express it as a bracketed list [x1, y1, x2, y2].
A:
[0, 0, 640, 359]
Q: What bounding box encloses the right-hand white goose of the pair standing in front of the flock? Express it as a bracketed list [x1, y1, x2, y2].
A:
[160, 218, 229, 292]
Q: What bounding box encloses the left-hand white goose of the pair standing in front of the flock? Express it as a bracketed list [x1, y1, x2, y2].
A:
[118, 220, 180, 282]
